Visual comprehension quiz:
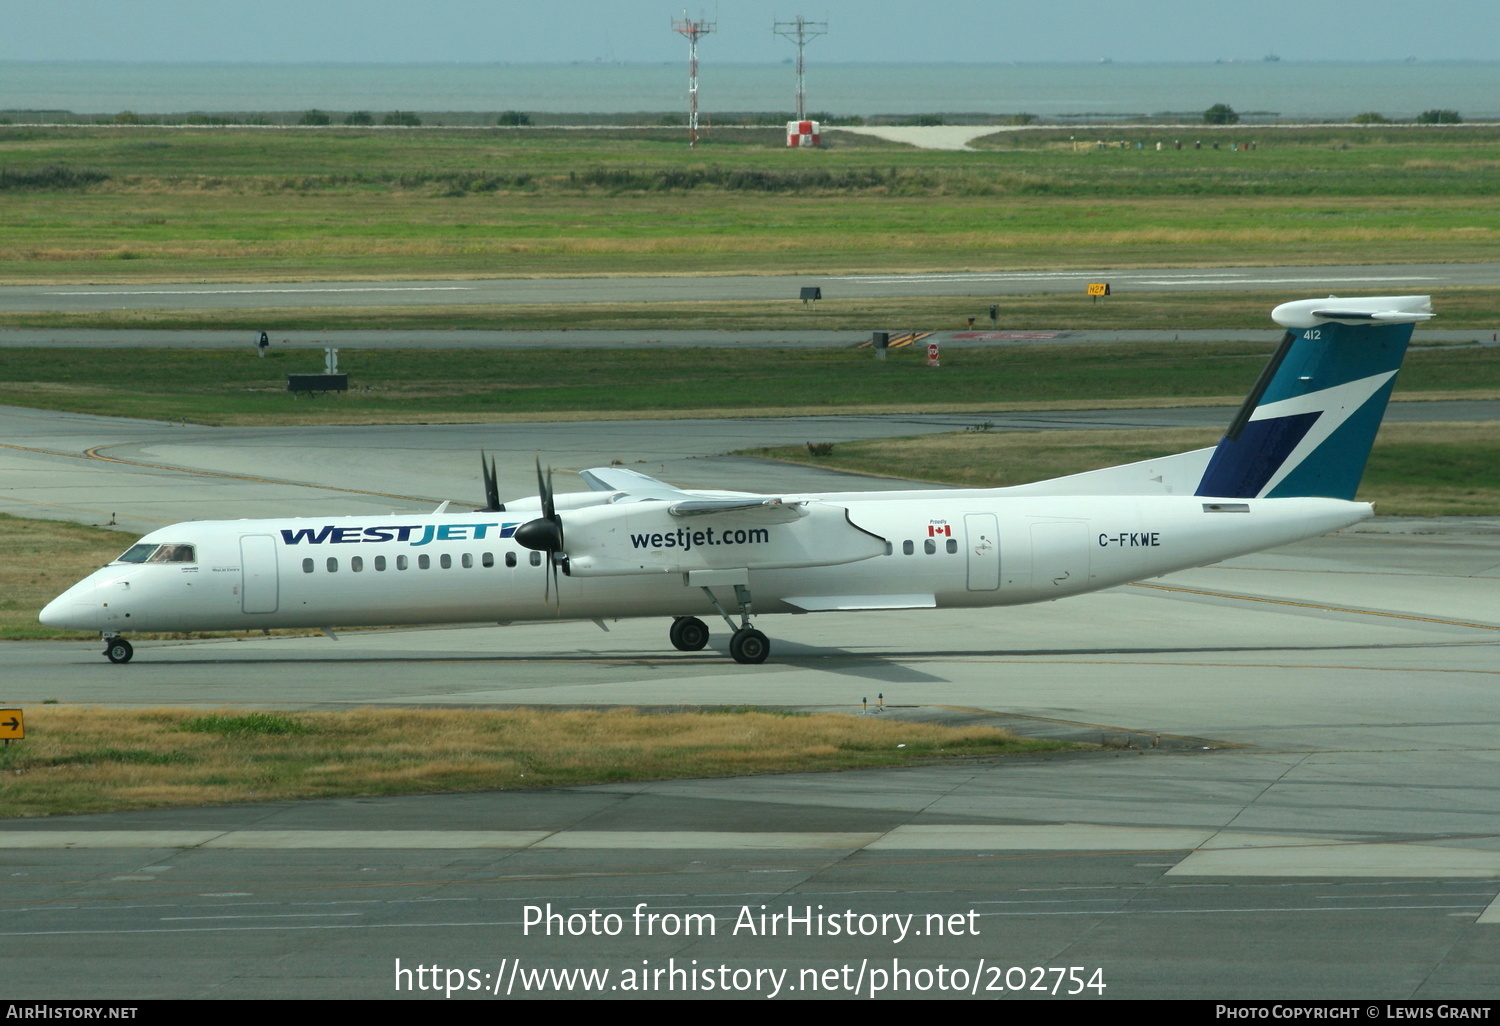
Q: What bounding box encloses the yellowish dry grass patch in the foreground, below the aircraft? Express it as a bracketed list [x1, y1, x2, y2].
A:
[0, 705, 1076, 818]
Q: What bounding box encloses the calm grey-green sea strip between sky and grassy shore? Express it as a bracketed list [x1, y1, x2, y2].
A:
[0, 59, 1500, 120]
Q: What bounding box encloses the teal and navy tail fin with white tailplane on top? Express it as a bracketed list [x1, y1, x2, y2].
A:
[1197, 296, 1433, 500]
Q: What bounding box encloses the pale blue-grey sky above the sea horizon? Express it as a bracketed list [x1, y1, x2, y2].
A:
[0, 0, 1500, 63]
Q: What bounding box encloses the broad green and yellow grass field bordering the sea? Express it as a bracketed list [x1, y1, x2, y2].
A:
[0, 126, 1500, 282]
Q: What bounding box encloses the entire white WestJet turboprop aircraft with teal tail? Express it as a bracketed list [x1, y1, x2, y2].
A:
[41, 296, 1433, 663]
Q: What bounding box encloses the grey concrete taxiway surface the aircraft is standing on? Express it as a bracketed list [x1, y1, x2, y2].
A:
[0, 404, 1500, 1001]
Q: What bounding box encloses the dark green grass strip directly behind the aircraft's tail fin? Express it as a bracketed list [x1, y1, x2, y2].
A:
[0, 332, 1500, 425]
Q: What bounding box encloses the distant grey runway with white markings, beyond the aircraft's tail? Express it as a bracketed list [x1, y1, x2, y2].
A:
[0, 264, 1500, 314]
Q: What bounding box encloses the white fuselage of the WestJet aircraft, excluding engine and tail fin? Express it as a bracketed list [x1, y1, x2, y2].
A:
[42, 491, 1371, 633]
